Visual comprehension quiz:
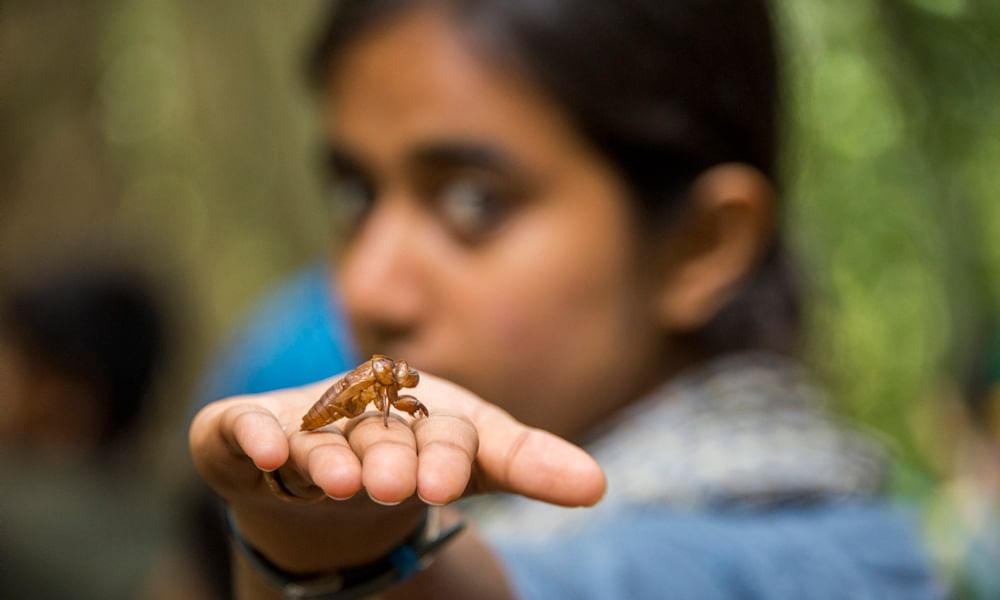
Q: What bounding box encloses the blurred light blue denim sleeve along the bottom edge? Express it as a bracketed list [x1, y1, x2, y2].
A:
[496, 503, 944, 600]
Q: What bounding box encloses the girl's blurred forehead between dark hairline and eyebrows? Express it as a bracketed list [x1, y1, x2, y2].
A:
[326, 10, 589, 171]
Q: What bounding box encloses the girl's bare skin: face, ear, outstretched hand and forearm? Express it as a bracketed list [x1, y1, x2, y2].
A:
[191, 7, 772, 598]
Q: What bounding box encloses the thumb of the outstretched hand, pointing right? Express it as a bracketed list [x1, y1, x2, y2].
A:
[471, 403, 607, 506]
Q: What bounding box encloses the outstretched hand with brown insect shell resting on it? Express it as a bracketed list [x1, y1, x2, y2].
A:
[190, 374, 606, 562]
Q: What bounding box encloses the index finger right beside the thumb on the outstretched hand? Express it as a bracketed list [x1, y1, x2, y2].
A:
[413, 411, 479, 504]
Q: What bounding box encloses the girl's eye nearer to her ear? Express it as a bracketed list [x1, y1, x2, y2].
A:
[437, 179, 508, 240]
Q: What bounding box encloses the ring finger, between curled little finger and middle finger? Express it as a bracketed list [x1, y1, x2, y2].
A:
[290, 427, 362, 500]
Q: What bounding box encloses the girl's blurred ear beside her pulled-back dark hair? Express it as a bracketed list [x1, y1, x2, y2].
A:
[657, 163, 775, 332]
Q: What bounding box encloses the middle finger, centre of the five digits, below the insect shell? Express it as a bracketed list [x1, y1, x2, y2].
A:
[347, 413, 417, 504]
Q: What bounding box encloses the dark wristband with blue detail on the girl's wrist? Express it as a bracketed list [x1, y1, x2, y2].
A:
[226, 506, 465, 600]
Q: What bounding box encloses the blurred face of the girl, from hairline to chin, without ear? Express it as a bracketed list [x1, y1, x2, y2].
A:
[327, 13, 666, 436]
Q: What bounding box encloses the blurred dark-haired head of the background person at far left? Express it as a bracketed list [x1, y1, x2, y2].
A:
[0, 263, 164, 463]
